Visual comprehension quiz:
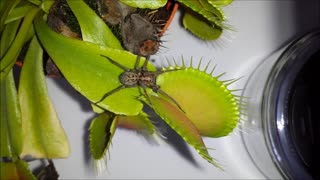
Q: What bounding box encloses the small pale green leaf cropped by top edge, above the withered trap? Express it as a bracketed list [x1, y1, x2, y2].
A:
[120, 0, 167, 9]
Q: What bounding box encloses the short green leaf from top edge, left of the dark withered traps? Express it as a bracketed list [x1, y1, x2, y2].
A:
[67, 0, 122, 49]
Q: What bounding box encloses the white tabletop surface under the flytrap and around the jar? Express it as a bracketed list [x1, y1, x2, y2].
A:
[43, 0, 320, 179]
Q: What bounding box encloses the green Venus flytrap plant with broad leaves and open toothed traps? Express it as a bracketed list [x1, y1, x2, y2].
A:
[0, 0, 239, 179]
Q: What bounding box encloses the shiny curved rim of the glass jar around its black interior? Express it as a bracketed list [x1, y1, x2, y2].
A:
[261, 30, 320, 179]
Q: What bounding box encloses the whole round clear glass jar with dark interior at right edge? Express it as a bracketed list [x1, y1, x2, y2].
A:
[241, 30, 320, 179]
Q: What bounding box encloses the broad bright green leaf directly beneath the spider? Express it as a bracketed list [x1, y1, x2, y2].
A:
[35, 16, 155, 115]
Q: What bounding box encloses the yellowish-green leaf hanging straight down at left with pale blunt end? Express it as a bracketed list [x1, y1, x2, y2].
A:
[19, 37, 70, 159]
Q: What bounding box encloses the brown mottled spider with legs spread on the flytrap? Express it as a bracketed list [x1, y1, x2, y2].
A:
[95, 55, 184, 112]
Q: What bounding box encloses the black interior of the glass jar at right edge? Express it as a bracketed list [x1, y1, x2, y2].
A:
[288, 51, 320, 179]
